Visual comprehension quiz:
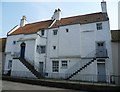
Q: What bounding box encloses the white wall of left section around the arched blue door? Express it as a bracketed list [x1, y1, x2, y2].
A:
[4, 34, 36, 77]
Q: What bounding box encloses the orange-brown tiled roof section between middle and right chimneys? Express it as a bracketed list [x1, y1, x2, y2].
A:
[52, 12, 109, 27]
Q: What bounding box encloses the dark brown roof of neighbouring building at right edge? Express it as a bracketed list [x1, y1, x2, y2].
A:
[111, 30, 120, 42]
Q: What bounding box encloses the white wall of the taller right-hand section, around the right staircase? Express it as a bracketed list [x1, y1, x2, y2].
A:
[46, 21, 112, 80]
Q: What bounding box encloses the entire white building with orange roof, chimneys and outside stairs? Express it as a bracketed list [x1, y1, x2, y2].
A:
[4, 1, 113, 82]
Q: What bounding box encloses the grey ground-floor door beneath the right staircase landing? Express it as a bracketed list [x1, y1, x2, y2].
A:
[97, 63, 106, 82]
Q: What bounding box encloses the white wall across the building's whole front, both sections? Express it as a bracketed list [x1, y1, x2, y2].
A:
[5, 21, 112, 79]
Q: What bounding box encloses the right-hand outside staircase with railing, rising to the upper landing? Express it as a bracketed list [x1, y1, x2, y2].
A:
[65, 49, 108, 80]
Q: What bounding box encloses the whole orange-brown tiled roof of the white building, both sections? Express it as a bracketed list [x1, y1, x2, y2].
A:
[9, 12, 109, 35]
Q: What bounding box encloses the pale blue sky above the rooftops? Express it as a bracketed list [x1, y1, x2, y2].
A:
[0, 0, 119, 37]
